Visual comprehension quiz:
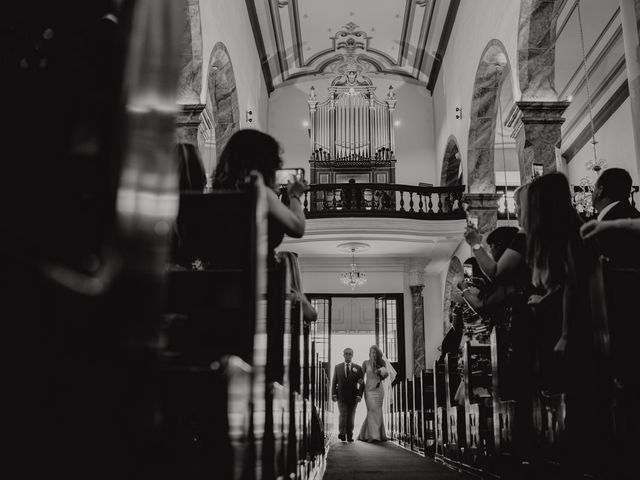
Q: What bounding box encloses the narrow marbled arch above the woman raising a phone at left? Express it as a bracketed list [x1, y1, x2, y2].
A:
[205, 42, 240, 156]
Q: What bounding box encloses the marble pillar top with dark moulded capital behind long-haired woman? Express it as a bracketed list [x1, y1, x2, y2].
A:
[512, 101, 569, 185]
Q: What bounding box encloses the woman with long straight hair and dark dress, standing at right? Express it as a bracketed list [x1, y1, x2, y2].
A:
[525, 173, 610, 478]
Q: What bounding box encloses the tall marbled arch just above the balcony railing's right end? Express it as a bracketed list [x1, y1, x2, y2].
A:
[467, 40, 513, 194]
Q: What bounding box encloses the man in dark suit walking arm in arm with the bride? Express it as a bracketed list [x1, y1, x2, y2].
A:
[331, 348, 364, 442]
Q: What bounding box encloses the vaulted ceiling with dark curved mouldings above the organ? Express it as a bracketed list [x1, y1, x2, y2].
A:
[246, 0, 460, 90]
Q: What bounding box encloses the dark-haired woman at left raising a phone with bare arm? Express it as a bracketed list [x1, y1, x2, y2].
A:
[213, 129, 309, 251]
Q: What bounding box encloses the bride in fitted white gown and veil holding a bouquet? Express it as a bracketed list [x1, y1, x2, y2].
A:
[358, 345, 396, 442]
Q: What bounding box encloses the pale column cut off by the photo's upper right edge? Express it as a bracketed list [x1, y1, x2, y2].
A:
[620, 0, 640, 176]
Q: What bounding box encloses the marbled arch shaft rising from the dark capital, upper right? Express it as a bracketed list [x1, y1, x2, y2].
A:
[518, 0, 564, 102]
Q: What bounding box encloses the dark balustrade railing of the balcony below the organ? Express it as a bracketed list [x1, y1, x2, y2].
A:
[284, 183, 465, 220]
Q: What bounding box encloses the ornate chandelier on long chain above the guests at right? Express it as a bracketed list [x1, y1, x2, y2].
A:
[573, 2, 608, 217]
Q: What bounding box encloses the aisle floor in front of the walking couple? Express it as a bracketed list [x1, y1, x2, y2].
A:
[323, 441, 474, 480]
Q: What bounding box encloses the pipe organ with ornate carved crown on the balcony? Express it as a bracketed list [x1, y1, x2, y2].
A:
[307, 71, 396, 183]
